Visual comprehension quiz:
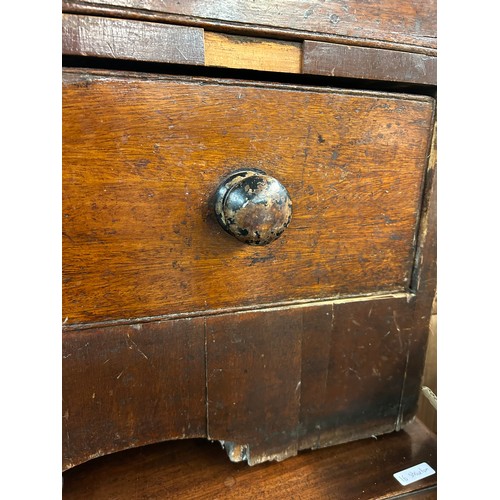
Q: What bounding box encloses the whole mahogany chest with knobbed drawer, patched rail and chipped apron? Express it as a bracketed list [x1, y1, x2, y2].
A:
[62, 0, 436, 470]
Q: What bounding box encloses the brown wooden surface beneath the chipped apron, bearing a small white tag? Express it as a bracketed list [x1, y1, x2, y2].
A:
[62, 421, 439, 500]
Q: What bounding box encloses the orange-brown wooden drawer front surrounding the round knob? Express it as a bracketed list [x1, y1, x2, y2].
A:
[63, 70, 434, 324]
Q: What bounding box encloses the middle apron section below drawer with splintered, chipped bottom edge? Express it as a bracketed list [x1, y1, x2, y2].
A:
[207, 309, 302, 465]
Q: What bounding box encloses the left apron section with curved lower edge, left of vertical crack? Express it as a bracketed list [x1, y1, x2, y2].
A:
[62, 319, 206, 470]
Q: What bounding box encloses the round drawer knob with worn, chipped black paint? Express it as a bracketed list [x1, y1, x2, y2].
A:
[215, 168, 292, 245]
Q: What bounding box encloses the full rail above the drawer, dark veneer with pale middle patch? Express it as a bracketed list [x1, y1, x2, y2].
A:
[62, 14, 437, 85]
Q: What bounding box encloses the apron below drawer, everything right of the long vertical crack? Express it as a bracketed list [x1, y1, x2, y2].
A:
[207, 296, 427, 465]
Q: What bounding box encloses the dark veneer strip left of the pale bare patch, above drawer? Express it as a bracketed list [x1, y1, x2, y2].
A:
[62, 14, 205, 65]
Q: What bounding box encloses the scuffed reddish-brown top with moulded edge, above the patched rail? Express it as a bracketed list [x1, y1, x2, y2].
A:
[63, 0, 437, 51]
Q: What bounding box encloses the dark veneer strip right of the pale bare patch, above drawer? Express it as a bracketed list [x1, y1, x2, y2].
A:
[302, 40, 437, 85]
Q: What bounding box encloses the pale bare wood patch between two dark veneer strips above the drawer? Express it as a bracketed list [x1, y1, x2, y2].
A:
[205, 31, 302, 73]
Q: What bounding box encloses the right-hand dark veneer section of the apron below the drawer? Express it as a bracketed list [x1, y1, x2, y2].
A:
[300, 298, 414, 449]
